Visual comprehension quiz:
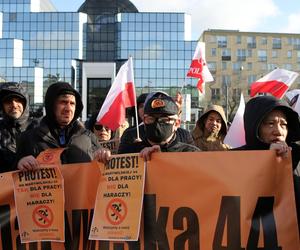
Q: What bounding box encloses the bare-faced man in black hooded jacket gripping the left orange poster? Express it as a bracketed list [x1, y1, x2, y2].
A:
[17, 82, 100, 170]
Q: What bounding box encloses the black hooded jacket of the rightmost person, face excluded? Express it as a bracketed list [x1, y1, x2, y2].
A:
[235, 96, 300, 229]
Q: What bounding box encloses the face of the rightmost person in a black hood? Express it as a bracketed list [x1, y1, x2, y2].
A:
[259, 110, 288, 144]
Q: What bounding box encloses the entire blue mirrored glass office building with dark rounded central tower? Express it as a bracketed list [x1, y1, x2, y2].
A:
[0, 0, 198, 120]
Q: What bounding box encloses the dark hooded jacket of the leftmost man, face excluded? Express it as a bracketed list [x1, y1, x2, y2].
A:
[0, 82, 38, 173]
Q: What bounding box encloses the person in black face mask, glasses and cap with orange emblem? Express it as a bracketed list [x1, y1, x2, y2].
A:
[119, 92, 199, 153]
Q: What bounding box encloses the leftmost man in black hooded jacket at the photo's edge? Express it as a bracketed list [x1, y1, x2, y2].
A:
[0, 82, 38, 173]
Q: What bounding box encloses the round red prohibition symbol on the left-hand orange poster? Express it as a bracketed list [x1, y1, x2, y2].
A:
[32, 205, 53, 228]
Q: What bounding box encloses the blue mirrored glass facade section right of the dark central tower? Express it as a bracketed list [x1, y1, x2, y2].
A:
[117, 13, 197, 96]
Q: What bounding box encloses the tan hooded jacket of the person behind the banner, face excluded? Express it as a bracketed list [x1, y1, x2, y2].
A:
[192, 105, 230, 151]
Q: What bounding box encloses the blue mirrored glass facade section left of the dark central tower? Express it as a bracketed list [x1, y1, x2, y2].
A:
[0, 0, 86, 103]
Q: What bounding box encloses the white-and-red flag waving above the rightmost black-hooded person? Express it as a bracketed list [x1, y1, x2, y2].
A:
[250, 69, 299, 99]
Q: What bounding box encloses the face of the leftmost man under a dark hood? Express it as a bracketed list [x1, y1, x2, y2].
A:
[3, 96, 24, 119]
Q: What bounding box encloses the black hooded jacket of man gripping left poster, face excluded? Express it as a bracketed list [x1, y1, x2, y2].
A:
[17, 82, 100, 164]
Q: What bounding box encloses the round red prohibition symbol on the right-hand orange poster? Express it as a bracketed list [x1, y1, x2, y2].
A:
[106, 199, 127, 225]
